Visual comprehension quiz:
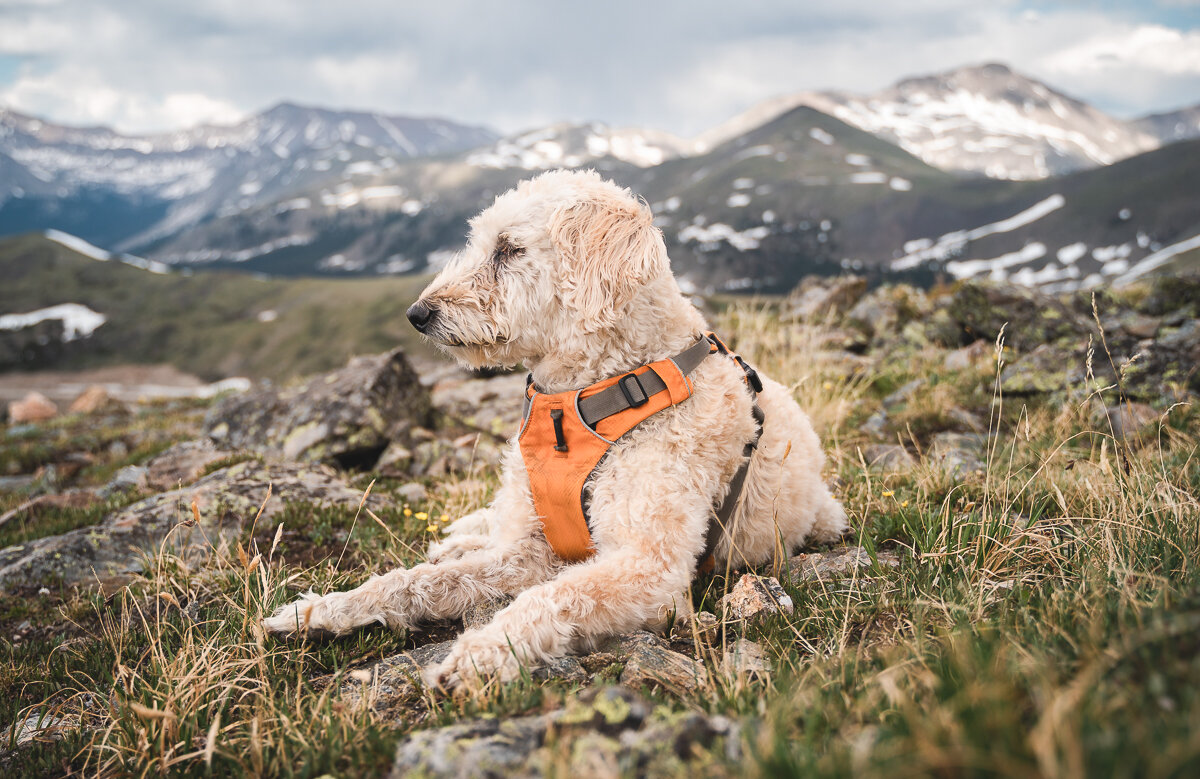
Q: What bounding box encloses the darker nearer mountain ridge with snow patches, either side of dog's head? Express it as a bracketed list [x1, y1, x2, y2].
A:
[103, 107, 1200, 292]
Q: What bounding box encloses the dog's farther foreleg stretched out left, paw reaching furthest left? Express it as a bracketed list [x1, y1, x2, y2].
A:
[263, 538, 557, 635]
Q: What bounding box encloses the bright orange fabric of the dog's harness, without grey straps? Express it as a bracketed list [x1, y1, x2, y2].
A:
[517, 355, 700, 563]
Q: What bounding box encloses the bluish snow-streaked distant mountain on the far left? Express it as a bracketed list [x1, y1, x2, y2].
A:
[0, 103, 496, 248]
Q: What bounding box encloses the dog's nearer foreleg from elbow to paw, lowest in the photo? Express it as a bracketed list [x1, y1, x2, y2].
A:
[427, 501, 707, 689]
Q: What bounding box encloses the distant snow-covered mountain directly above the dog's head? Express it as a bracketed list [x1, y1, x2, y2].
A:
[467, 122, 698, 170]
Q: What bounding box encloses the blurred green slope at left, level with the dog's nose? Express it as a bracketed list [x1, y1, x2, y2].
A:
[0, 235, 425, 379]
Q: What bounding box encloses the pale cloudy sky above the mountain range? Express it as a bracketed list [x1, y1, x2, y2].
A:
[0, 0, 1200, 134]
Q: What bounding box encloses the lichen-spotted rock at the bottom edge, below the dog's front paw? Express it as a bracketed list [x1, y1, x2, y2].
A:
[390, 687, 740, 779]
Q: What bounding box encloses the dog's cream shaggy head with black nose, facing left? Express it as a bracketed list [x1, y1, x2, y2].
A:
[408, 170, 671, 367]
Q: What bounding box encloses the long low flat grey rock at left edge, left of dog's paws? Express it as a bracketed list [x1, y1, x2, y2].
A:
[0, 461, 377, 592]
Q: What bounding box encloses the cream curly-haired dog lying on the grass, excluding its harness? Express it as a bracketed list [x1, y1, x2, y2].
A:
[264, 170, 846, 688]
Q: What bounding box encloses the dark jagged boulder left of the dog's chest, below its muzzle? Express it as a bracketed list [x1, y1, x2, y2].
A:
[205, 349, 432, 468]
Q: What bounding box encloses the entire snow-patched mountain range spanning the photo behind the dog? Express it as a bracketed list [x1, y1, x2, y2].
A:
[0, 65, 1200, 292]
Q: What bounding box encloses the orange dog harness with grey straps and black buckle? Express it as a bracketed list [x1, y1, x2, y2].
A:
[517, 332, 762, 563]
